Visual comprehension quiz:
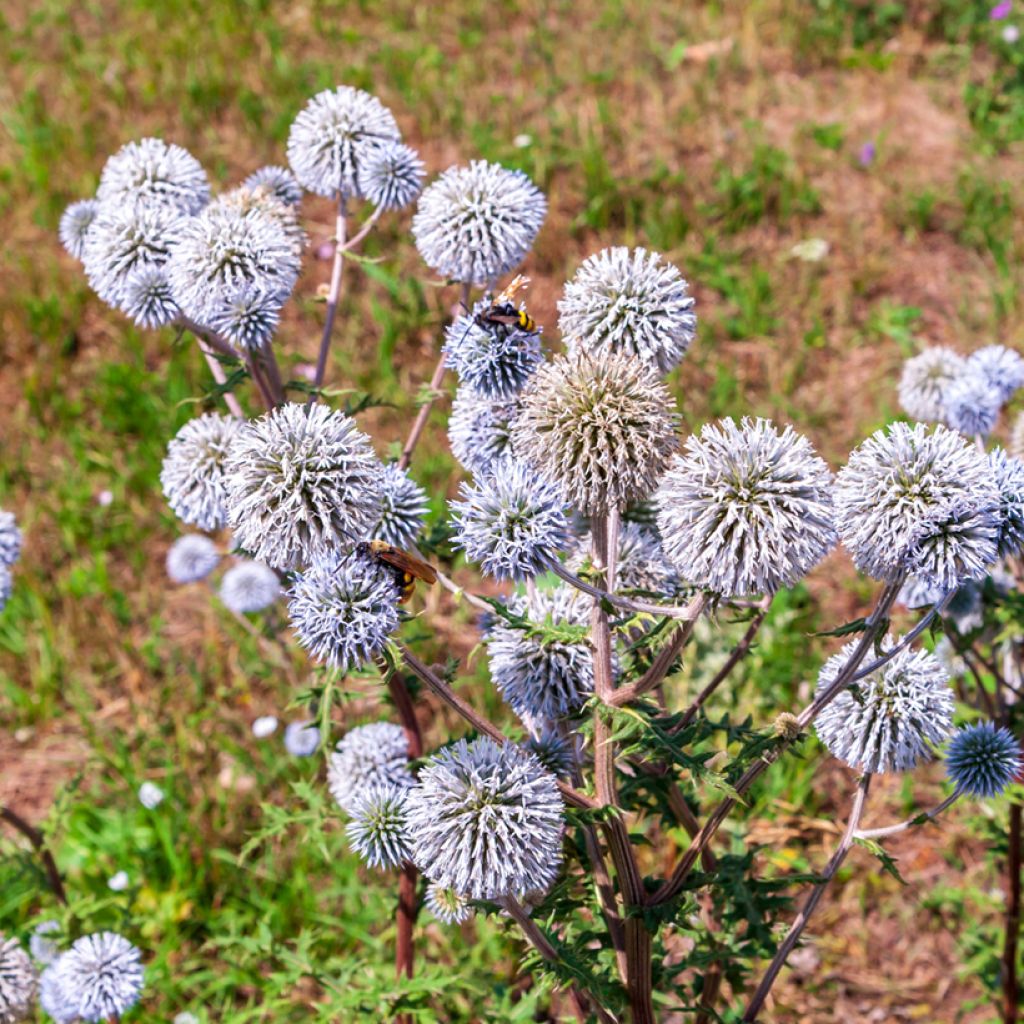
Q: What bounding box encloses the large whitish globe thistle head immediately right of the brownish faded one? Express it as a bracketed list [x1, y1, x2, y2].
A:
[657, 419, 836, 597]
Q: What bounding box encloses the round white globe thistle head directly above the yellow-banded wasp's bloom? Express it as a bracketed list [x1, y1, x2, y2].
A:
[413, 160, 548, 285]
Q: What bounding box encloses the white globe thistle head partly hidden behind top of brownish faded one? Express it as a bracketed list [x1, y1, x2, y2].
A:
[558, 246, 697, 374]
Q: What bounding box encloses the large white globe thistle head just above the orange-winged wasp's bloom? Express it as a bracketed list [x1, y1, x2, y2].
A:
[224, 402, 383, 569]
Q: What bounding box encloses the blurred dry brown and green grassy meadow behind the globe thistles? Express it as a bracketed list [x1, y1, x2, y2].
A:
[0, 0, 1024, 1024]
